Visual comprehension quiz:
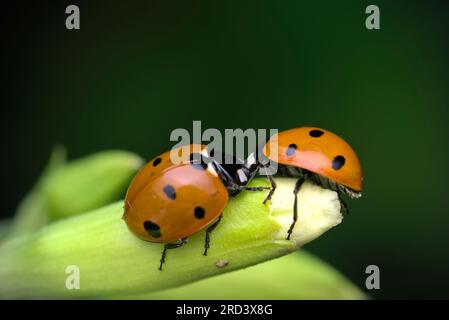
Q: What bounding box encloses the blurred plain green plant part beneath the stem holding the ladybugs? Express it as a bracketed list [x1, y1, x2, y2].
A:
[119, 250, 367, 300]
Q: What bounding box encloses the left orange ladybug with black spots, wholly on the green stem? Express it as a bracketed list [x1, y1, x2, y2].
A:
[123, 145, 264, 270]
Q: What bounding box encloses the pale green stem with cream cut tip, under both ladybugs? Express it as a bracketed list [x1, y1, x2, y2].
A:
[0, 179, 342, 298]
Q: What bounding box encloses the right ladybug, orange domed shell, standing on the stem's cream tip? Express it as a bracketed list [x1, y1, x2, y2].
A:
[261, 127, 363, 240]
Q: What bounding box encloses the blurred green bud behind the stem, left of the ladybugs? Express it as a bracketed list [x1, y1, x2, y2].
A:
[8, 146, 144, 238]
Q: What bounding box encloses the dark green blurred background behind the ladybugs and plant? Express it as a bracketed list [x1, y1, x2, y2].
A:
[0, 0, 449, 298]
